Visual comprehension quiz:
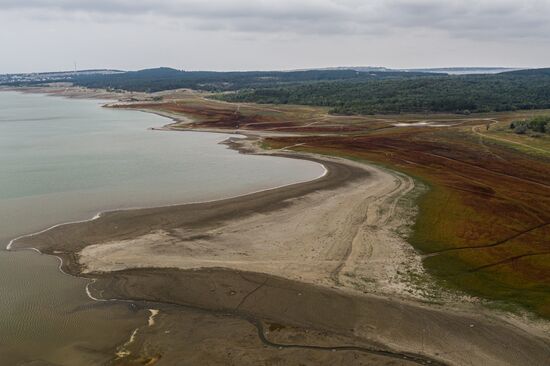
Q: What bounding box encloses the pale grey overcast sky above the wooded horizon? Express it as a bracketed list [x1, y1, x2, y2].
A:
[0, 0, 550, 73]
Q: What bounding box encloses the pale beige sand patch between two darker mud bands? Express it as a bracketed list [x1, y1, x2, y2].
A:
[75, 157, 420, 292]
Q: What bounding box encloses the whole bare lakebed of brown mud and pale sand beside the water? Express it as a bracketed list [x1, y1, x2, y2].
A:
[10, 125, 550, 365]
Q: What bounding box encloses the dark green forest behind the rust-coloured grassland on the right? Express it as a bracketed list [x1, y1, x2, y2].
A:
[219, 69, 550, 114]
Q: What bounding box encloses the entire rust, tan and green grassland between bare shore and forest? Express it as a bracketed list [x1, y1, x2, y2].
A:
[114, 94, 550, 319]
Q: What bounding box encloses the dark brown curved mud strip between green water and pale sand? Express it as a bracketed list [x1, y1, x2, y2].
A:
[8, 153, 360, 268]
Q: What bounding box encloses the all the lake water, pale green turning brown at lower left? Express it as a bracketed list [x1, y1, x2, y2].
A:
[0, 92, 323, 365]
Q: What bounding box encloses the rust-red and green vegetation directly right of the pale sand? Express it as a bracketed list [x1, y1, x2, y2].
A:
[267, 133, 550, 318]
